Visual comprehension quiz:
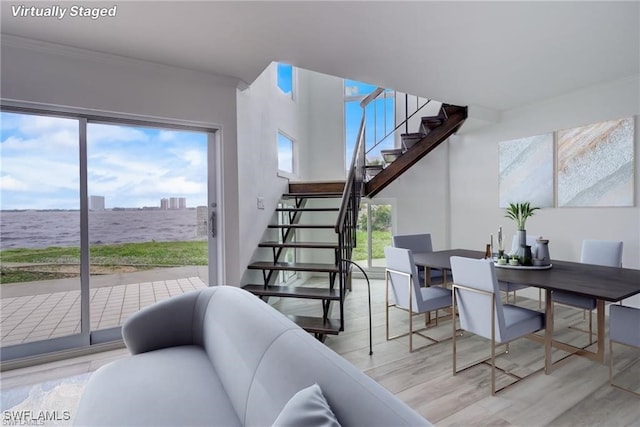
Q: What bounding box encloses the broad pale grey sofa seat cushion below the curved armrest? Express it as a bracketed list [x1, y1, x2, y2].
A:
[74, 346, 241, 426]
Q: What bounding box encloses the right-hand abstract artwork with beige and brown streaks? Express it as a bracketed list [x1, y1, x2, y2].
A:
[557, 117, 634, 206]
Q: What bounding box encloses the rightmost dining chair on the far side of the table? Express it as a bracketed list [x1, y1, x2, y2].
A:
[551, 239, 622, 345]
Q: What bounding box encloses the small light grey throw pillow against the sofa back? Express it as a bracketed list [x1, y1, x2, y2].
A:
[273, 384, 340, 427]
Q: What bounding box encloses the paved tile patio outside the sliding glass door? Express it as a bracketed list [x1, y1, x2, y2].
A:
[0, 277, 206, 347]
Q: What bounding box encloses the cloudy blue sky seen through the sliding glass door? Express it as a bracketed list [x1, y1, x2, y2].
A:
[0, 112, 207, 209]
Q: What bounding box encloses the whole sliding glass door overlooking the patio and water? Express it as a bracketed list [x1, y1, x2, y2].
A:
[0, 110, 220, 361]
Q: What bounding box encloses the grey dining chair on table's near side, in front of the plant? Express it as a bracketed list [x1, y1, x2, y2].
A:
[451, 256, 545, 395]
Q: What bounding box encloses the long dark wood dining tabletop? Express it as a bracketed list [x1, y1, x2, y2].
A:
[413, 249, 640, 302]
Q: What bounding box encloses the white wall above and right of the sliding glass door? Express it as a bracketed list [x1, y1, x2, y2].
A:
[1, 35, 244, 283]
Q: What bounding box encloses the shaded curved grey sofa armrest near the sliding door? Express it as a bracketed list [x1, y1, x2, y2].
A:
[122, 288, 213, 354]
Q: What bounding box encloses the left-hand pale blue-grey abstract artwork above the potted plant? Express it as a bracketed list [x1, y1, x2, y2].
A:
[498, 133, 553, 208]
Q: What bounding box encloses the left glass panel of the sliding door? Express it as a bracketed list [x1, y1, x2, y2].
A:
[0, 112, 81, 350]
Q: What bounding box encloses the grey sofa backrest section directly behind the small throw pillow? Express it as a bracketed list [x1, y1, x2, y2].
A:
[244, 328, 430, 427]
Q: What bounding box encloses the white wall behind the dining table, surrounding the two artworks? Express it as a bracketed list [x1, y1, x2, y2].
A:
[449, 76, 640, 268]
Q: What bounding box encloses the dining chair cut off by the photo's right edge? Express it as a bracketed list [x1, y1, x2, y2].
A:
[609, 305, 640, 397]
